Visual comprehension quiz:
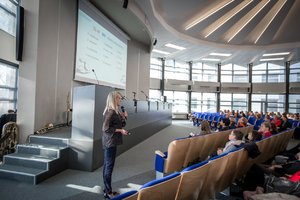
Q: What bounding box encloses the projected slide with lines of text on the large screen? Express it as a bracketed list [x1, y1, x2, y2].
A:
[75, 9, 127, 89]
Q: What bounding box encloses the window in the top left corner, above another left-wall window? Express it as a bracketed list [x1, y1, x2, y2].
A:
[0, 0, 18, 36]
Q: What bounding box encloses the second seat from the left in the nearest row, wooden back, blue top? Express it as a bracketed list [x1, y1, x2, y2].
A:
[138, 172, 181, 200]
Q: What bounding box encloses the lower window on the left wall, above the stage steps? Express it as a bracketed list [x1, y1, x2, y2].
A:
[0, 61, 17, 114]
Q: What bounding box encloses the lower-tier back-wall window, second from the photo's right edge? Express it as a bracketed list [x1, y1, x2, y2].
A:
[251, 94, 285, 113]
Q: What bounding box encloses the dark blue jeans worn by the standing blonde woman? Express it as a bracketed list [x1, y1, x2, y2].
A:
[103, 146, 117, 194]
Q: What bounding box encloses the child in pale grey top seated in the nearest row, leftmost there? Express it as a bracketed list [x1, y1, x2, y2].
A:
[217, 129, 244, 155]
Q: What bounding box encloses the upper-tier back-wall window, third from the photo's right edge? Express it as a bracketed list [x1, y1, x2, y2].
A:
[221, 64, 249, 83]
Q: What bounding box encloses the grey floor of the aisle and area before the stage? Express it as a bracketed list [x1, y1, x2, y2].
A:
[0, 120, 199, 200]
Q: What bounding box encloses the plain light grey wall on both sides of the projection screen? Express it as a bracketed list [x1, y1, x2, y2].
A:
[13, 0, 150, 143]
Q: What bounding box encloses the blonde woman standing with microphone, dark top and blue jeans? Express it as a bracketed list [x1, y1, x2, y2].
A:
[102, 91, 128, 199]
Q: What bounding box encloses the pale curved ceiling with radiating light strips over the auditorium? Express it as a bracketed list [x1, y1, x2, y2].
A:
[91, 0, 300, 65]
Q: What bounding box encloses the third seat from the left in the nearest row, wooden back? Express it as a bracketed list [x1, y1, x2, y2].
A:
[176, 161, 210, 200]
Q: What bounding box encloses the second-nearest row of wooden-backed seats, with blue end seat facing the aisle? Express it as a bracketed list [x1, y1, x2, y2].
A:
[155, 126, 253, 178]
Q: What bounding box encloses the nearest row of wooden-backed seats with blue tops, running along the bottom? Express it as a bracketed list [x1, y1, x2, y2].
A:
[114, 129, 293, 200]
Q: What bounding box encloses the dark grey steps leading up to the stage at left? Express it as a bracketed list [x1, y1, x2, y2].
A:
[0, 136, 69, 184]
